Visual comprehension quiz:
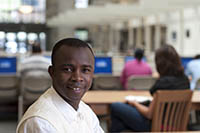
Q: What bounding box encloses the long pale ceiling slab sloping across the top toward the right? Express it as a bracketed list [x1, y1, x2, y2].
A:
[47, 0, 200, 27]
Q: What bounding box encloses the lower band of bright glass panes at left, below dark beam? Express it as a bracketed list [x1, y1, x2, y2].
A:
[0, 31, 46, 53]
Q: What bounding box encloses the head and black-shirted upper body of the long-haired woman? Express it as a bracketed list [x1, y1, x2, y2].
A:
[150, 45, 190, 95]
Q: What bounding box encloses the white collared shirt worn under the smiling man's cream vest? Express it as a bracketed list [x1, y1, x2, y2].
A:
[20, 89, 104, 133]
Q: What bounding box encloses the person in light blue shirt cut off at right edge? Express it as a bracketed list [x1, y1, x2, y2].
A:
[185, 55, 200, 90]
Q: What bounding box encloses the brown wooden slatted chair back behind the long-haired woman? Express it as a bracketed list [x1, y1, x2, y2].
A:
[151, 90, 192, 132]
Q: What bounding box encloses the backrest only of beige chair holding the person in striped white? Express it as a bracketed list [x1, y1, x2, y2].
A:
[20, 69, 51, 101]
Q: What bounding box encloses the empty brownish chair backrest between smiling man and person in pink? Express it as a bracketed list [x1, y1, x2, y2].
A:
[92, 74, 122, 90]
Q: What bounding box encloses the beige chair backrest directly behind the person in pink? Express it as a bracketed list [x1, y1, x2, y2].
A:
[127, 76, 156, 90]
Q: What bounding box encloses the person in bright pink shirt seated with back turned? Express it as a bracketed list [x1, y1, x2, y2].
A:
[120, 48, 152, 89]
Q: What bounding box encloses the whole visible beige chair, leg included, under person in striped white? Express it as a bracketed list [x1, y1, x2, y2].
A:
[18, 68, 51, 120]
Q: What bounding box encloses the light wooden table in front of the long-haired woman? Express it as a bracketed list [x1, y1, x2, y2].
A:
[82, 90, 200, 115]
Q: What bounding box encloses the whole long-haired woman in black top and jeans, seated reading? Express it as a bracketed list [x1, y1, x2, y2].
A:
[111, 45, 190, 132]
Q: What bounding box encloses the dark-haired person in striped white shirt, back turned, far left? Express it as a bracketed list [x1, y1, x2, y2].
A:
[20, 43, 50, 74]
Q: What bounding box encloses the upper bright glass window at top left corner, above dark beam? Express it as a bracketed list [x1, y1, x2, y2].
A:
[0, 0, 46, 24]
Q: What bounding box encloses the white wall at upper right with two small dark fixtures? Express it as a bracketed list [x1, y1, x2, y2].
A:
[166, 9, 200, 57]
